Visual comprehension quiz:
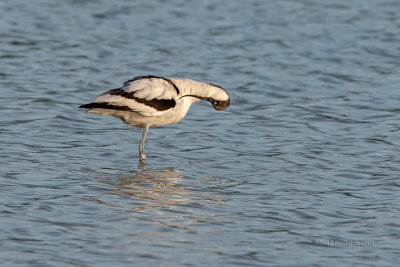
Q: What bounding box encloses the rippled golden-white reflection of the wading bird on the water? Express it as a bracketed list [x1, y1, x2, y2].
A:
[92, 164, 225, 235]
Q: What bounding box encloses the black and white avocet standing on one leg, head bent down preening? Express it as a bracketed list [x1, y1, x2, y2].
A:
[80, 75, 230, 160]
